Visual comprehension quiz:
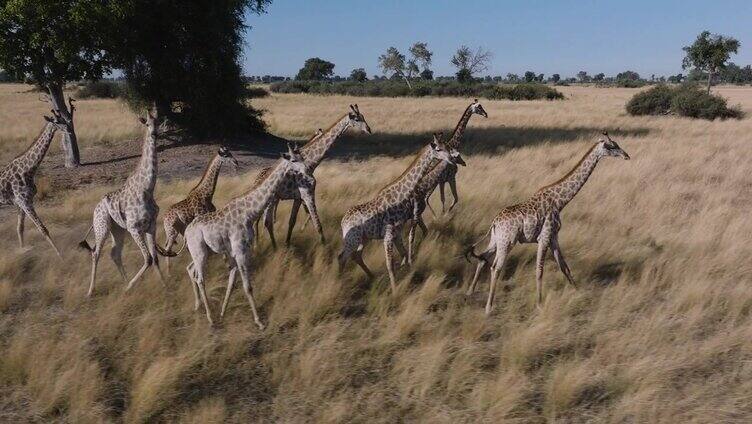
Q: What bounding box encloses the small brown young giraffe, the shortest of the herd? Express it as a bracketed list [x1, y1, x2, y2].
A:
[162, 146, 238, 273]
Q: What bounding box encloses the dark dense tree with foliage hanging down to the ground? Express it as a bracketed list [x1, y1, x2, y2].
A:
[112, 0, 271, 137]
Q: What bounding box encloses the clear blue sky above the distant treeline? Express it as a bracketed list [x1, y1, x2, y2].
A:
[243, 0, 752, 77]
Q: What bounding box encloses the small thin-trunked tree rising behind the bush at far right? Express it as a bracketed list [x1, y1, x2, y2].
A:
[682, 31, 740, 94]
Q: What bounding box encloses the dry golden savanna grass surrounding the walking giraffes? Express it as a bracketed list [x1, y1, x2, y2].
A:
[0, 86, 752, 423]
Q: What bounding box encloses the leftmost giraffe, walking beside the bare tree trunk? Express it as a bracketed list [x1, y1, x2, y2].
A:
[0, 111, 73, 256]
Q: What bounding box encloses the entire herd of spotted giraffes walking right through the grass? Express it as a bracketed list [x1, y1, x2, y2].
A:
[0, 99, 629, 329]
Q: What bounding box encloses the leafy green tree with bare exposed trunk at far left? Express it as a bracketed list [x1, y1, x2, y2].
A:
[0, 0, 116, 167]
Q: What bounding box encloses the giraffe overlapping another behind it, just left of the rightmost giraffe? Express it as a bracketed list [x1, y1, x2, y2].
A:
[338, 134, 464, 294]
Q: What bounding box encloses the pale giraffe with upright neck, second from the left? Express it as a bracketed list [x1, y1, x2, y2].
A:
[79, 109, 175, 297]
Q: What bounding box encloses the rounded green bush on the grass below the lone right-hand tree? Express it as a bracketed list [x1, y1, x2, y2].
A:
[626, 84, 743, 120]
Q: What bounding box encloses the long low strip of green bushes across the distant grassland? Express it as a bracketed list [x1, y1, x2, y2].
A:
[270, 80, 564, 100]
